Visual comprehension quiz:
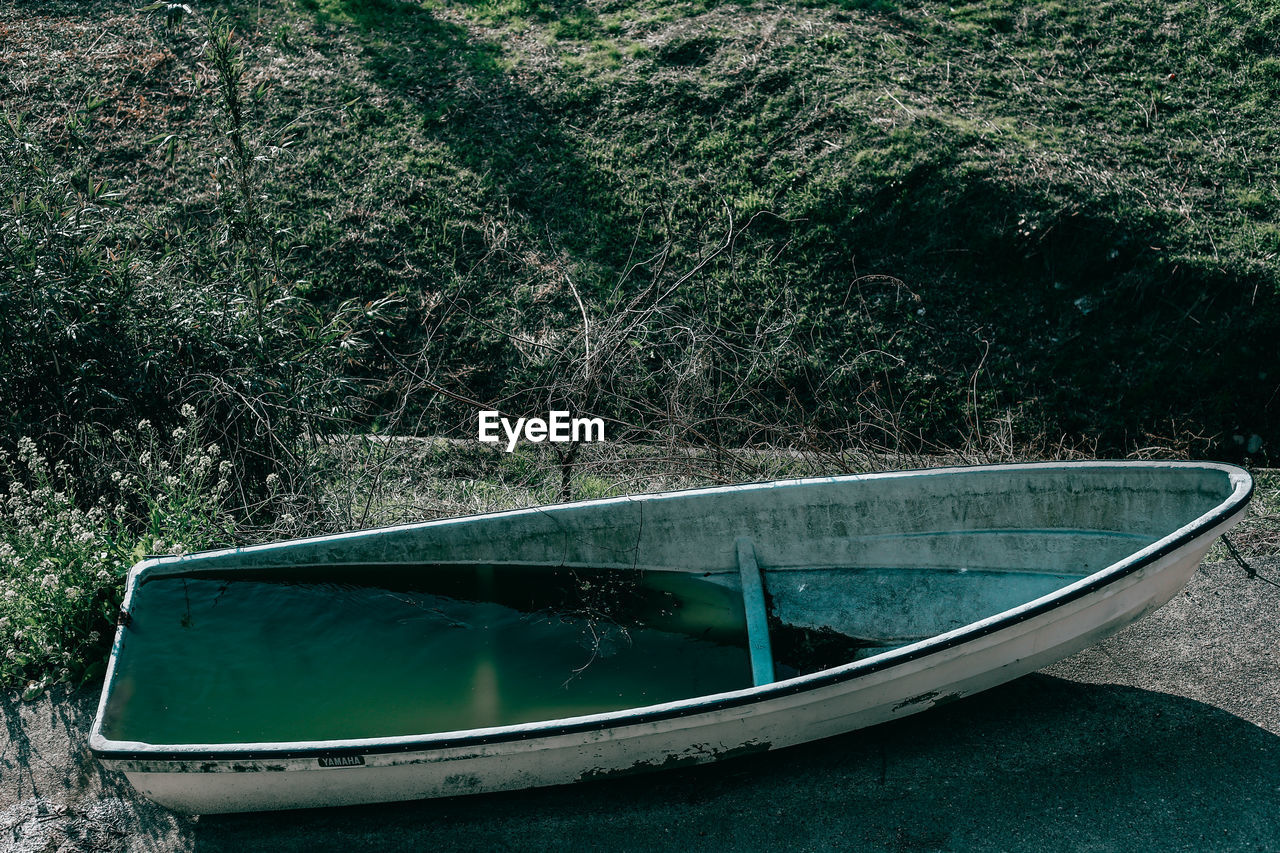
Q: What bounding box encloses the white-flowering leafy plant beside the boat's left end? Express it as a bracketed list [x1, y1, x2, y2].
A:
[0, 406, 233, 695]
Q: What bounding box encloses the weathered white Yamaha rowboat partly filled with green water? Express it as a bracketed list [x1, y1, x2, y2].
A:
[90, 461, 1253, 813]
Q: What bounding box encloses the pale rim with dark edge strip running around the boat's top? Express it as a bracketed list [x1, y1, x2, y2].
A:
[88, 460, 1254, 758]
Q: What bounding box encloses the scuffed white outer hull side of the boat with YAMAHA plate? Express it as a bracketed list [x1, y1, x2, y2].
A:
[95, 458, 1244, 813]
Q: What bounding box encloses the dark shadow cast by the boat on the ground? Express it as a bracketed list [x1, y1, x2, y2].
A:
[193, 675, 1280, 850]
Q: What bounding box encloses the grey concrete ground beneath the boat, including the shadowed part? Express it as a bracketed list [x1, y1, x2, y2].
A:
[0, 560, 1280, 853]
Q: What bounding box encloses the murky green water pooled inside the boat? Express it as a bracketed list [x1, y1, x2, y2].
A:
[104, 566, 751, 744]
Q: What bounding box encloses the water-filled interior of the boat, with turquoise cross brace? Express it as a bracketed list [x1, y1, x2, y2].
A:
[104, 465, 1249, 743]
